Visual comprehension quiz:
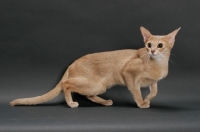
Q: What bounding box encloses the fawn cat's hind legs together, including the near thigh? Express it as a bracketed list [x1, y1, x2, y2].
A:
[63, 77, 113, 108]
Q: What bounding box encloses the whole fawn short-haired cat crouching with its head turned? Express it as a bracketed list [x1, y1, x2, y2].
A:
[10, 27, 180, 108]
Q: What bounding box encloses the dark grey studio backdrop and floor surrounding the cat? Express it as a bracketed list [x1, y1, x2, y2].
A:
[0, 0, 200, 132]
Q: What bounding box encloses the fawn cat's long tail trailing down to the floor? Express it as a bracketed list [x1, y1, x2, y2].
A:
[10, 81, 62, 106]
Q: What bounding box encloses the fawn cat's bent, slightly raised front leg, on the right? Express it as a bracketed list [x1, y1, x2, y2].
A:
[144, 83, 158, 104]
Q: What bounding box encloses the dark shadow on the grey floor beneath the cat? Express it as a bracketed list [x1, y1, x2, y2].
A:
[14, 94, 192, 112]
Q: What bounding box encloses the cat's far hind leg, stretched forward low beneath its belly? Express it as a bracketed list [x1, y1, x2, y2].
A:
[86, 96, 113, 106]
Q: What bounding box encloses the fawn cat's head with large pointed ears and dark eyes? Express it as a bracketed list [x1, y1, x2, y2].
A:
[140, 27, 180, 58]
